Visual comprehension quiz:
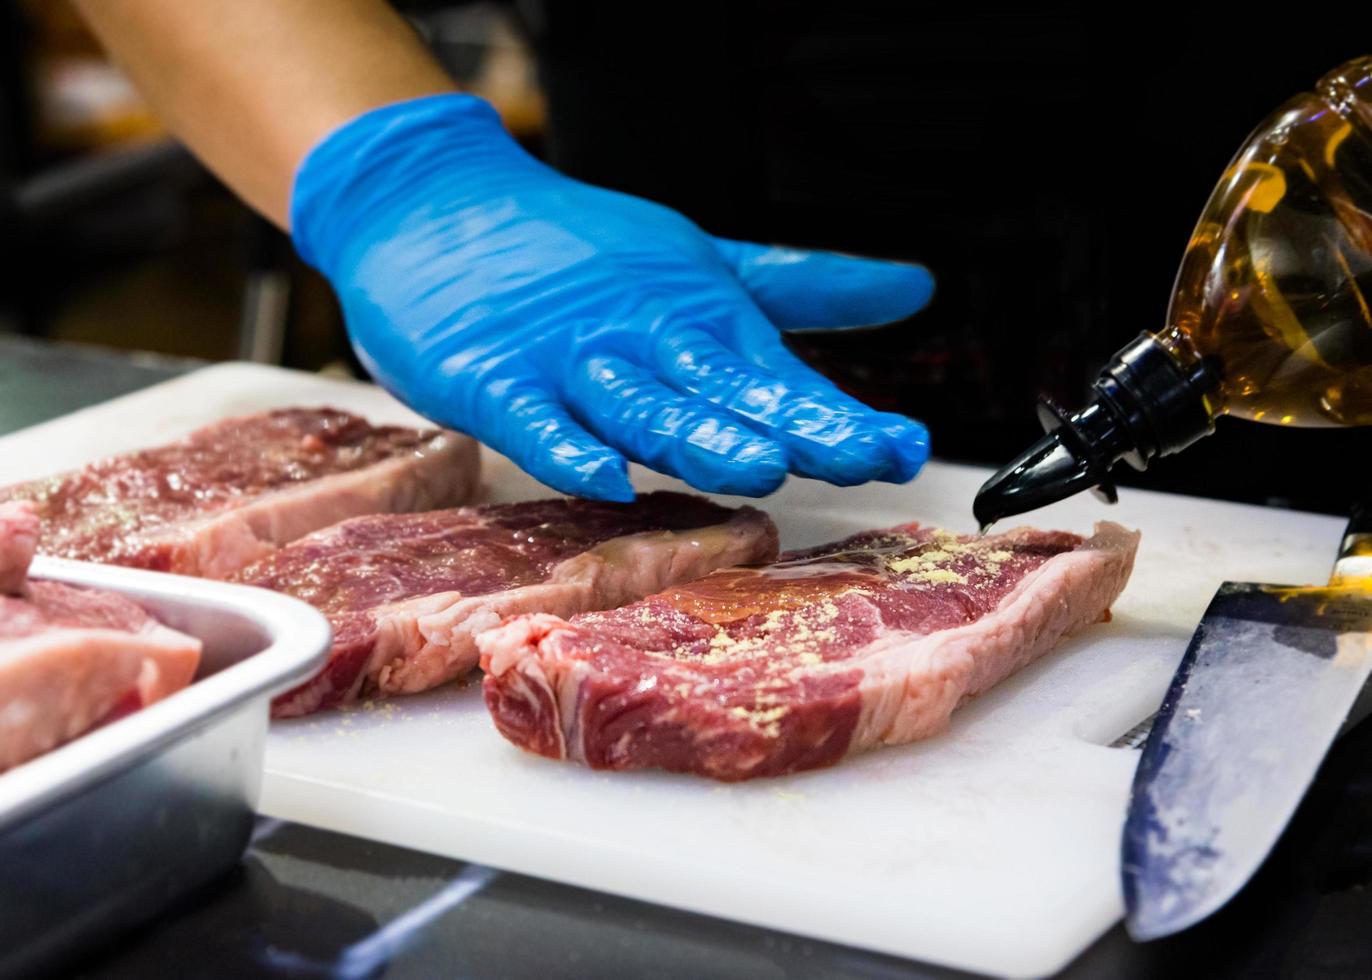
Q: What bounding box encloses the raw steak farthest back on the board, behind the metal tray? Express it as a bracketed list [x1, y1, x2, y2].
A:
[0, 408, 477, 578]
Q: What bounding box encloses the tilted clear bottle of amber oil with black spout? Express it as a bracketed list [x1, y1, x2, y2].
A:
[974, 58, 1372, 527]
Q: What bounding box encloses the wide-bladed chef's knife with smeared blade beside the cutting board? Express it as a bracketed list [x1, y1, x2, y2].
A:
[1122, 508, 1372, 940]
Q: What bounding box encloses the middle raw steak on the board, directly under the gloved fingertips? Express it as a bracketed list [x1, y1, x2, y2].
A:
[237, 493, 777, 716]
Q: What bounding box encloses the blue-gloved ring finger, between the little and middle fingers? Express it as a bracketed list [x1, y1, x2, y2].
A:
[568, 354, 786, 497]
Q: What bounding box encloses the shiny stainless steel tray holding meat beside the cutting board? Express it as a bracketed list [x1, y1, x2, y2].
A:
[0, 557, 329, 977]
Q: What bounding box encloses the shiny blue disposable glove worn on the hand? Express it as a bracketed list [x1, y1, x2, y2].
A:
[291, 95, 933, 500]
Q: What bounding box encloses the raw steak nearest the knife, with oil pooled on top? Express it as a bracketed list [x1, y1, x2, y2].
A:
[477, 523, 1139, 781]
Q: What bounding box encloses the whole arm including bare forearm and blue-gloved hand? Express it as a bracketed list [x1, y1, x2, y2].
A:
[72, 0, 932, 500]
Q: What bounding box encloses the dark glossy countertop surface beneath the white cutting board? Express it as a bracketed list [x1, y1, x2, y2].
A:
[8, 338, 1372, 980]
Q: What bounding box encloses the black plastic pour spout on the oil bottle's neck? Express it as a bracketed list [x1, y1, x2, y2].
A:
[971, 334, 1218, 530]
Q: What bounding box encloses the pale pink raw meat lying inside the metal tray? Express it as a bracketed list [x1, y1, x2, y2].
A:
[0, 502, 200, 773]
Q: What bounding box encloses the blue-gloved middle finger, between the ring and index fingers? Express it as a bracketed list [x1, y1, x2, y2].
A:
[656, 327, 890, 486]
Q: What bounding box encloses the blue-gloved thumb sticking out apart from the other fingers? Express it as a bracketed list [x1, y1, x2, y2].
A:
[713, 239, 934, 329]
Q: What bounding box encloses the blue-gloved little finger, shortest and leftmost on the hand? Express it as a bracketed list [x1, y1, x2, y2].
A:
[475, 373, 634, 502]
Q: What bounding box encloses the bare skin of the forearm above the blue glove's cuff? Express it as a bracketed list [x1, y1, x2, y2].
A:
[77, 0, 454, 228]
